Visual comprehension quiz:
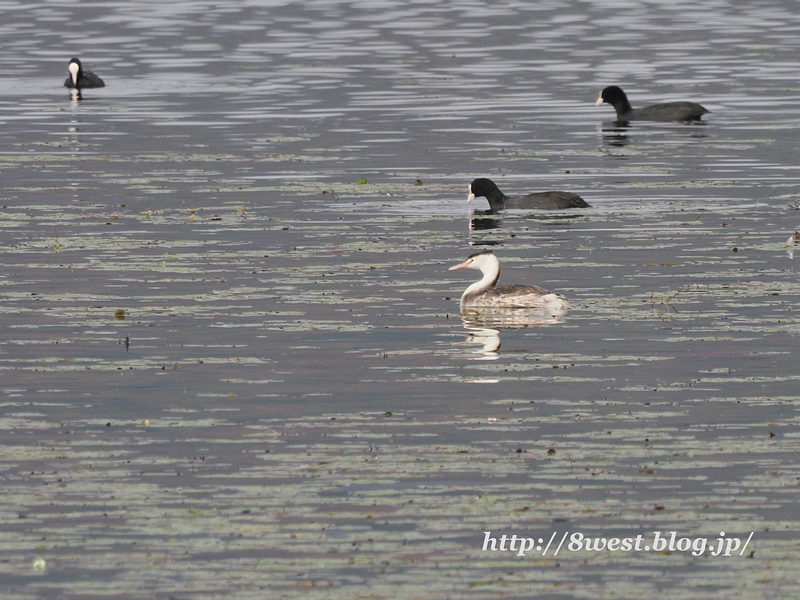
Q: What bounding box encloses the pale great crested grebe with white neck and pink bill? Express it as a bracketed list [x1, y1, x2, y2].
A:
[449, 250, 567, 313]
